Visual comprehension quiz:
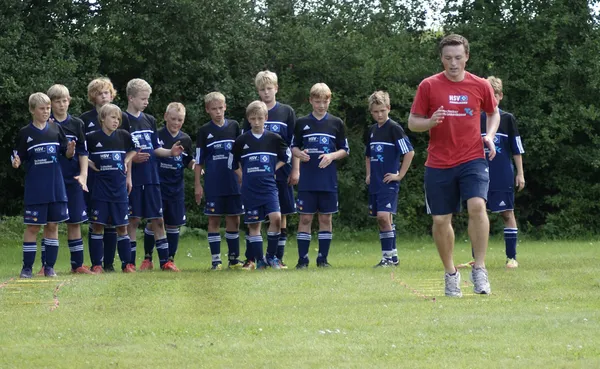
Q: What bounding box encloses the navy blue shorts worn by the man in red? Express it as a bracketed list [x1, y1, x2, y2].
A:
[425, 159, 490, 215]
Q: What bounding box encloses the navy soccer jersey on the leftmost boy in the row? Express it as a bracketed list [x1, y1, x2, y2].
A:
[16, 121, 68, 205]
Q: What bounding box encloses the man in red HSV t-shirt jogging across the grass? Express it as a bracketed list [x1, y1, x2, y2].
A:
[408, 34, 500, 297]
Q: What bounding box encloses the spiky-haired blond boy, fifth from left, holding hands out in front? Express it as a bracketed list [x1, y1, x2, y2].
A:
[127, 78, 184, 272]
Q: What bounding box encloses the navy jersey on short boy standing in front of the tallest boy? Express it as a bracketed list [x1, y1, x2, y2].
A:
[232, 130, 288, 201]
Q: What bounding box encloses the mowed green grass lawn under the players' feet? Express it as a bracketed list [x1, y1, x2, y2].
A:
[0, 232, 600, 368]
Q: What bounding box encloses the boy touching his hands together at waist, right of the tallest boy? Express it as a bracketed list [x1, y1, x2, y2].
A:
[292, 83, 350, 269]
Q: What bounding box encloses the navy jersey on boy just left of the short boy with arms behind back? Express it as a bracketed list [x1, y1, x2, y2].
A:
[196, 119, 240, 197]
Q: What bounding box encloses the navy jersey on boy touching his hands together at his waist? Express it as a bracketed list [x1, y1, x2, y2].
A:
[292, 113, 350, 192]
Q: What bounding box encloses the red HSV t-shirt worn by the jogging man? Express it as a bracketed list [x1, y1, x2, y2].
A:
[410, 72, 497, 168]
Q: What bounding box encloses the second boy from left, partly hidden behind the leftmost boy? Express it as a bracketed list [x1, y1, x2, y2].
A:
[47, 85, 92, 274]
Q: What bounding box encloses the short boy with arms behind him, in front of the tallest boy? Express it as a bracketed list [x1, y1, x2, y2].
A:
[230, 101, 289, 269]
